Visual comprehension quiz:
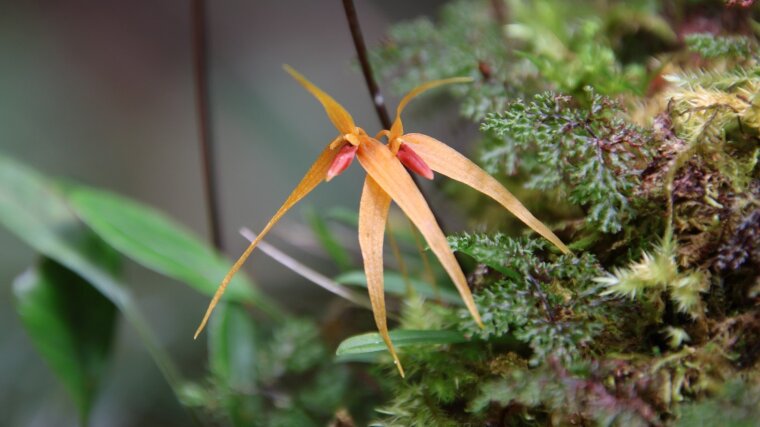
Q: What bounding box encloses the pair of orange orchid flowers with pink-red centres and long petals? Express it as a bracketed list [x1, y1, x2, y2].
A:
[195, 65, 570, 376]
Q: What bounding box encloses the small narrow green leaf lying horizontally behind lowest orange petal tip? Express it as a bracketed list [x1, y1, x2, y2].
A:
[335, 330, 468, 356]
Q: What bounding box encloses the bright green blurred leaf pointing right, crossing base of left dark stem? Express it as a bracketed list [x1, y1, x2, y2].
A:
[69, 187, 263, 303]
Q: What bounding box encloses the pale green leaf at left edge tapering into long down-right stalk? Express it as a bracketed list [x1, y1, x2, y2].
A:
[0, 155, 181, 408]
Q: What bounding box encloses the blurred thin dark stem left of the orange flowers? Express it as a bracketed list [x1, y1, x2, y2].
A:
[192, 0, 223, 249]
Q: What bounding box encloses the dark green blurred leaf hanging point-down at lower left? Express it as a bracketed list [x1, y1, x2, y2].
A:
[13, 260, 116, 425]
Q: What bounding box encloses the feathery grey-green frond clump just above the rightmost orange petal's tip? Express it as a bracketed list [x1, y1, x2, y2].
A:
[481, 88, 651, 233]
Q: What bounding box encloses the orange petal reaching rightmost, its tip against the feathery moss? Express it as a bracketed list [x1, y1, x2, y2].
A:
[401, 133, 570, 254]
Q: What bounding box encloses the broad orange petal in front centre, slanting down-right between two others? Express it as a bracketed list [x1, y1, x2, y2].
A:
[356, 138, 482, 325]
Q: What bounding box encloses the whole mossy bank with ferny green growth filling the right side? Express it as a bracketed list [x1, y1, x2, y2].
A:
[366, 1, 760, 425]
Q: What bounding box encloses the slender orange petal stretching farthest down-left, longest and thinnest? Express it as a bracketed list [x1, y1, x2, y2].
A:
[194, 147, 337, 338]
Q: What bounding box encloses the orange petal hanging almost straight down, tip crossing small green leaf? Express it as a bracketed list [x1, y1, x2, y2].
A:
[359, 176, 404, 377]
